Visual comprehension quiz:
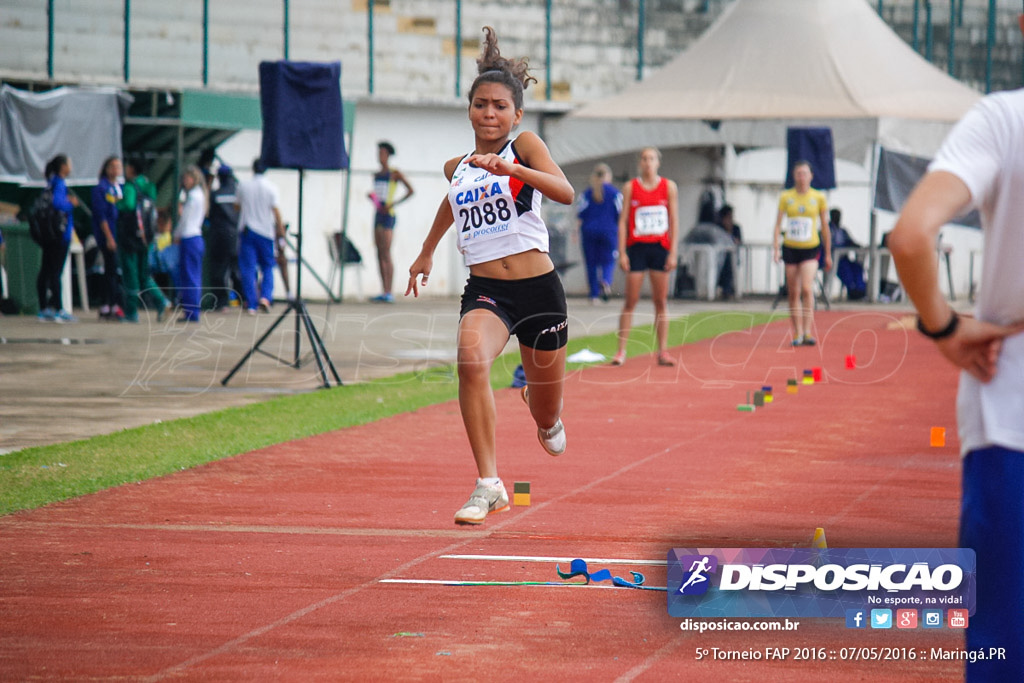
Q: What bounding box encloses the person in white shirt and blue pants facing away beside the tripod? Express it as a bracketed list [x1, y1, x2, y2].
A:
[236, 159, 285, 314]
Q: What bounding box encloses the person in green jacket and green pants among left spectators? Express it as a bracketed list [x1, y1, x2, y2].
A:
[118, 159, 171, 323]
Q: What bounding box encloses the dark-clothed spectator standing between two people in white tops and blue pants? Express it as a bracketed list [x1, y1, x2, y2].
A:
[206, 164, 242, 310]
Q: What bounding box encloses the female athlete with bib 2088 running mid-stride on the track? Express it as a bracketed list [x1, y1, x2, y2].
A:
[406, 27, 573, 524]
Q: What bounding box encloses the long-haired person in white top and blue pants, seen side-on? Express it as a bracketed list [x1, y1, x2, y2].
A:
[174, 166, 208, 323]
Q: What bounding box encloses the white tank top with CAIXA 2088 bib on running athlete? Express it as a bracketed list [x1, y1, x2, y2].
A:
[449, 140, 548, 265]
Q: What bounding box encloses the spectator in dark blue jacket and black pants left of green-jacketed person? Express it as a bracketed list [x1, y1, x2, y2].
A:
[91, 157, 125, 321]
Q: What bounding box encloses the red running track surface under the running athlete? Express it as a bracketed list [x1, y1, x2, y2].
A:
[0, 312, 963, 681]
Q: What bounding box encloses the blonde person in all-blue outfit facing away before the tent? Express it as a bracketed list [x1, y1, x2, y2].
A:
[577, 164, 623, 303]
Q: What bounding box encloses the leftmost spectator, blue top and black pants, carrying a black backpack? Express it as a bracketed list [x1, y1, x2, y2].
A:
[36, 155, 78, 323]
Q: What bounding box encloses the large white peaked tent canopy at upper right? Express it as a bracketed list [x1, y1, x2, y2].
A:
[549, 0, 980, 163]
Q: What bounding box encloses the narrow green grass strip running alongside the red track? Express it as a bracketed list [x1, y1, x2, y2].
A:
[0, 312, 773, 515]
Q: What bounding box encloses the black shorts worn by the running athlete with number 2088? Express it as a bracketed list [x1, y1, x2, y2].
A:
[461, 270, 569, 351]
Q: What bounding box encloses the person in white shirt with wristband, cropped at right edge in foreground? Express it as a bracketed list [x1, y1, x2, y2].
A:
[888, 14, 1024, 681]
